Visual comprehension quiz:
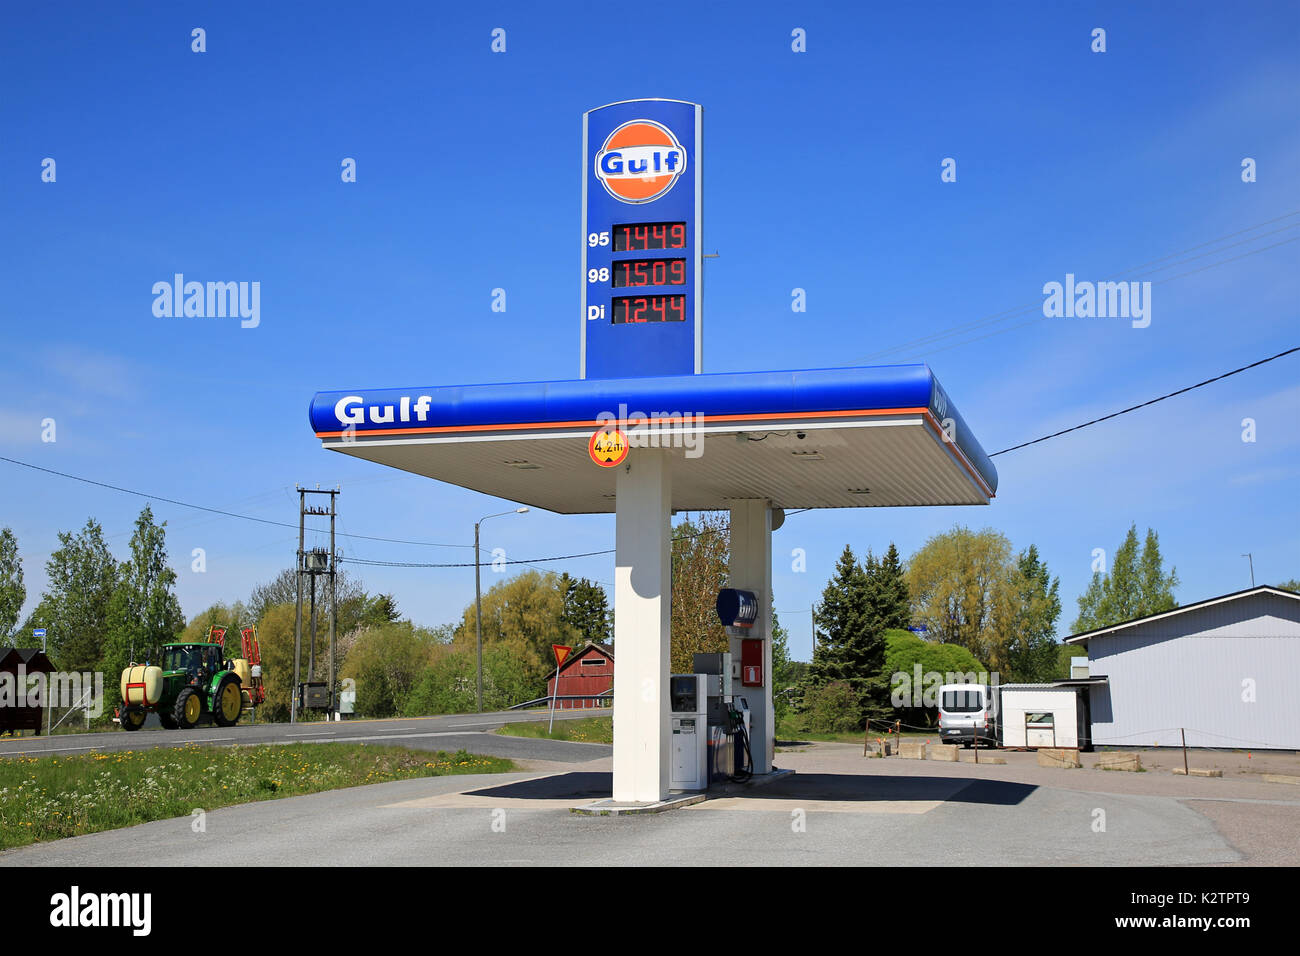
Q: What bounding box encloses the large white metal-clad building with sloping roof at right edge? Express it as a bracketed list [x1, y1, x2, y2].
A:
[1066, 587, 1300, 750]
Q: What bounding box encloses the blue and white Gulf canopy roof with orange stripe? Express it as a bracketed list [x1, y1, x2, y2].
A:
[311, 365, 997, 514]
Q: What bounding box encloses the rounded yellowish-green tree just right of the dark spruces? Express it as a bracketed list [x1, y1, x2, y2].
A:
[907, 525, 1021, 670]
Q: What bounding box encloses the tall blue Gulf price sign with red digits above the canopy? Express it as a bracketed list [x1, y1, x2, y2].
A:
[579, 99, 703, 378]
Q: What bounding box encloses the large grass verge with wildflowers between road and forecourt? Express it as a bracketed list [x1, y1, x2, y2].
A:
[0, 743, 515, 849]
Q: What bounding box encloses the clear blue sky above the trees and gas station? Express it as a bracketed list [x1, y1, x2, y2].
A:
[0, 3, 1300, 658]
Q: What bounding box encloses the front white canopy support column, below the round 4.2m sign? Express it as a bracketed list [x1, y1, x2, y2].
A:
[614, 449, 672, 803]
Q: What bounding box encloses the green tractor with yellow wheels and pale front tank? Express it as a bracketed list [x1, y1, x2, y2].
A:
[118, 634, 261, 730]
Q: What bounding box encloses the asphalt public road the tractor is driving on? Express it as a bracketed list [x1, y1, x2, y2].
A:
[0, 710, 610, 761]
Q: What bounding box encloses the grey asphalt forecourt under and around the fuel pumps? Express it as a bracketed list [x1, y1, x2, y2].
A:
[0, 737, 1300, 868]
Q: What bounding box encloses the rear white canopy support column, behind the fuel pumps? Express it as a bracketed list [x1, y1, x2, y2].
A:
[728, 498, 776, 774]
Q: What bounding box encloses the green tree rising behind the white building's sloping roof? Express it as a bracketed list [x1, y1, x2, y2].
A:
[1073, 522, 1178, 633]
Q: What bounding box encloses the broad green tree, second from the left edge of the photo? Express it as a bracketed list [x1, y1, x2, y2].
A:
[26, 518, 118, 671]
